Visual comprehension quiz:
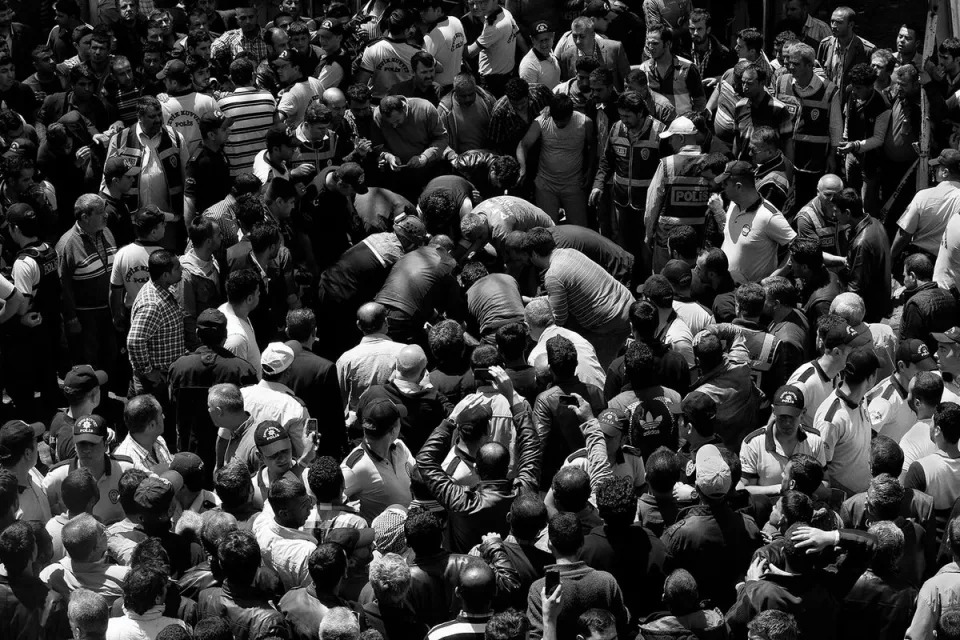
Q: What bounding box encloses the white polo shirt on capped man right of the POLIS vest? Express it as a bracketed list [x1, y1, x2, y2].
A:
[721, 198, 797, 282]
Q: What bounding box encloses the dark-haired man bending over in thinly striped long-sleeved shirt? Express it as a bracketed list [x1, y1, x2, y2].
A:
[524, 227, 633, 367]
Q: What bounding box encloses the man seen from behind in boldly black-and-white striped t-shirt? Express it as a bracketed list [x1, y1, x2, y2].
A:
[217, 58, 277, 176]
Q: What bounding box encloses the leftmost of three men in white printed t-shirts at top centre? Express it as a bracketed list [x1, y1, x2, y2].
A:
[354, 9, 420, 101]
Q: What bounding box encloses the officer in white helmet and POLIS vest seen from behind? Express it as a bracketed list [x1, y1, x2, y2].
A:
[643, 117, 710, 273]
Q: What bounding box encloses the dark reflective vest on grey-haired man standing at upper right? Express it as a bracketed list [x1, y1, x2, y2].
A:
[776, 74, 837, 173]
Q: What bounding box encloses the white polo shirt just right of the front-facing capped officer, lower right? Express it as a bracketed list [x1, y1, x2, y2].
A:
[814, 389, 873, 496]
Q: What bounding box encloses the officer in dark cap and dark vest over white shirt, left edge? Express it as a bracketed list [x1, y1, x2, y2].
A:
[3, 203, 61, 422]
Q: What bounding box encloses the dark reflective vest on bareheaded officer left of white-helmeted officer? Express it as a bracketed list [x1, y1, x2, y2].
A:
[609, 118, 664, 209]
